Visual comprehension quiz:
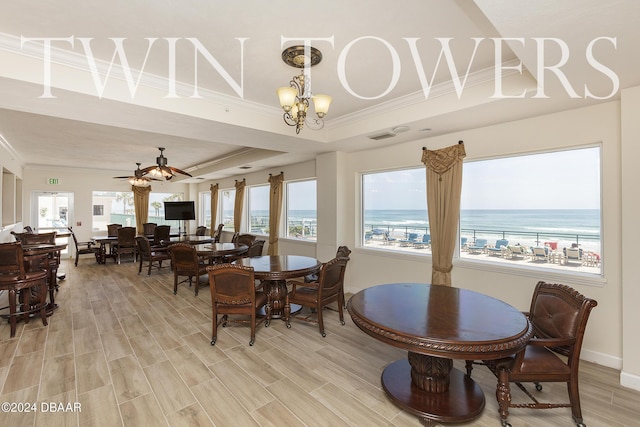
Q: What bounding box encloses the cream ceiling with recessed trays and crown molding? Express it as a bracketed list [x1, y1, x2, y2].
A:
[0, 0, 640, 182]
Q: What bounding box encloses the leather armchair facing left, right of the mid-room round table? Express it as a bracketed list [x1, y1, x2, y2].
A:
[284, 257, 349, 337]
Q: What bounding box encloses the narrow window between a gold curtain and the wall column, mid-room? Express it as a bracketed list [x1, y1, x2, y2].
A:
[285, 180, 318, 240]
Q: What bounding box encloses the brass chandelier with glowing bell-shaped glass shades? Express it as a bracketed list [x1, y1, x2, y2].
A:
[276, 46, 331, 133]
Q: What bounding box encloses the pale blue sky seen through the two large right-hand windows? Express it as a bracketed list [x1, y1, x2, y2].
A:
[363, 147, 600, 209]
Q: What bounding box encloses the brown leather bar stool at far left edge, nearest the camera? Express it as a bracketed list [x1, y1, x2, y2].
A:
[0, 242, 48, 338]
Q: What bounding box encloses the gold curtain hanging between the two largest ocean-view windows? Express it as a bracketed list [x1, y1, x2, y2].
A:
[422, 141, 466, 286]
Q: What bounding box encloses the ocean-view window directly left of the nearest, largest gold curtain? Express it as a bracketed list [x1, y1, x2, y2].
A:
[362, 167, 430, 253]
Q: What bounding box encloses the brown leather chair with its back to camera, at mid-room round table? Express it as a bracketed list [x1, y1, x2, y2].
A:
[207, 263, 271, 345]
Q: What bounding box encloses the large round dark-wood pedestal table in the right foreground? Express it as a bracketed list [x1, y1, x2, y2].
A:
[347, 283, 533, 425]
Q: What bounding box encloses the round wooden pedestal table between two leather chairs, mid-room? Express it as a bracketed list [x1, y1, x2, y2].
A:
[234, 255, 322, 318]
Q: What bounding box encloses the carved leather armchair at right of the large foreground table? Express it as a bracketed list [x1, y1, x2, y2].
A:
[466, 281, 598, 427]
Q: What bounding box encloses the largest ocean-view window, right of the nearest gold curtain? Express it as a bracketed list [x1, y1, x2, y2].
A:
[460, 147, 602, 274]
